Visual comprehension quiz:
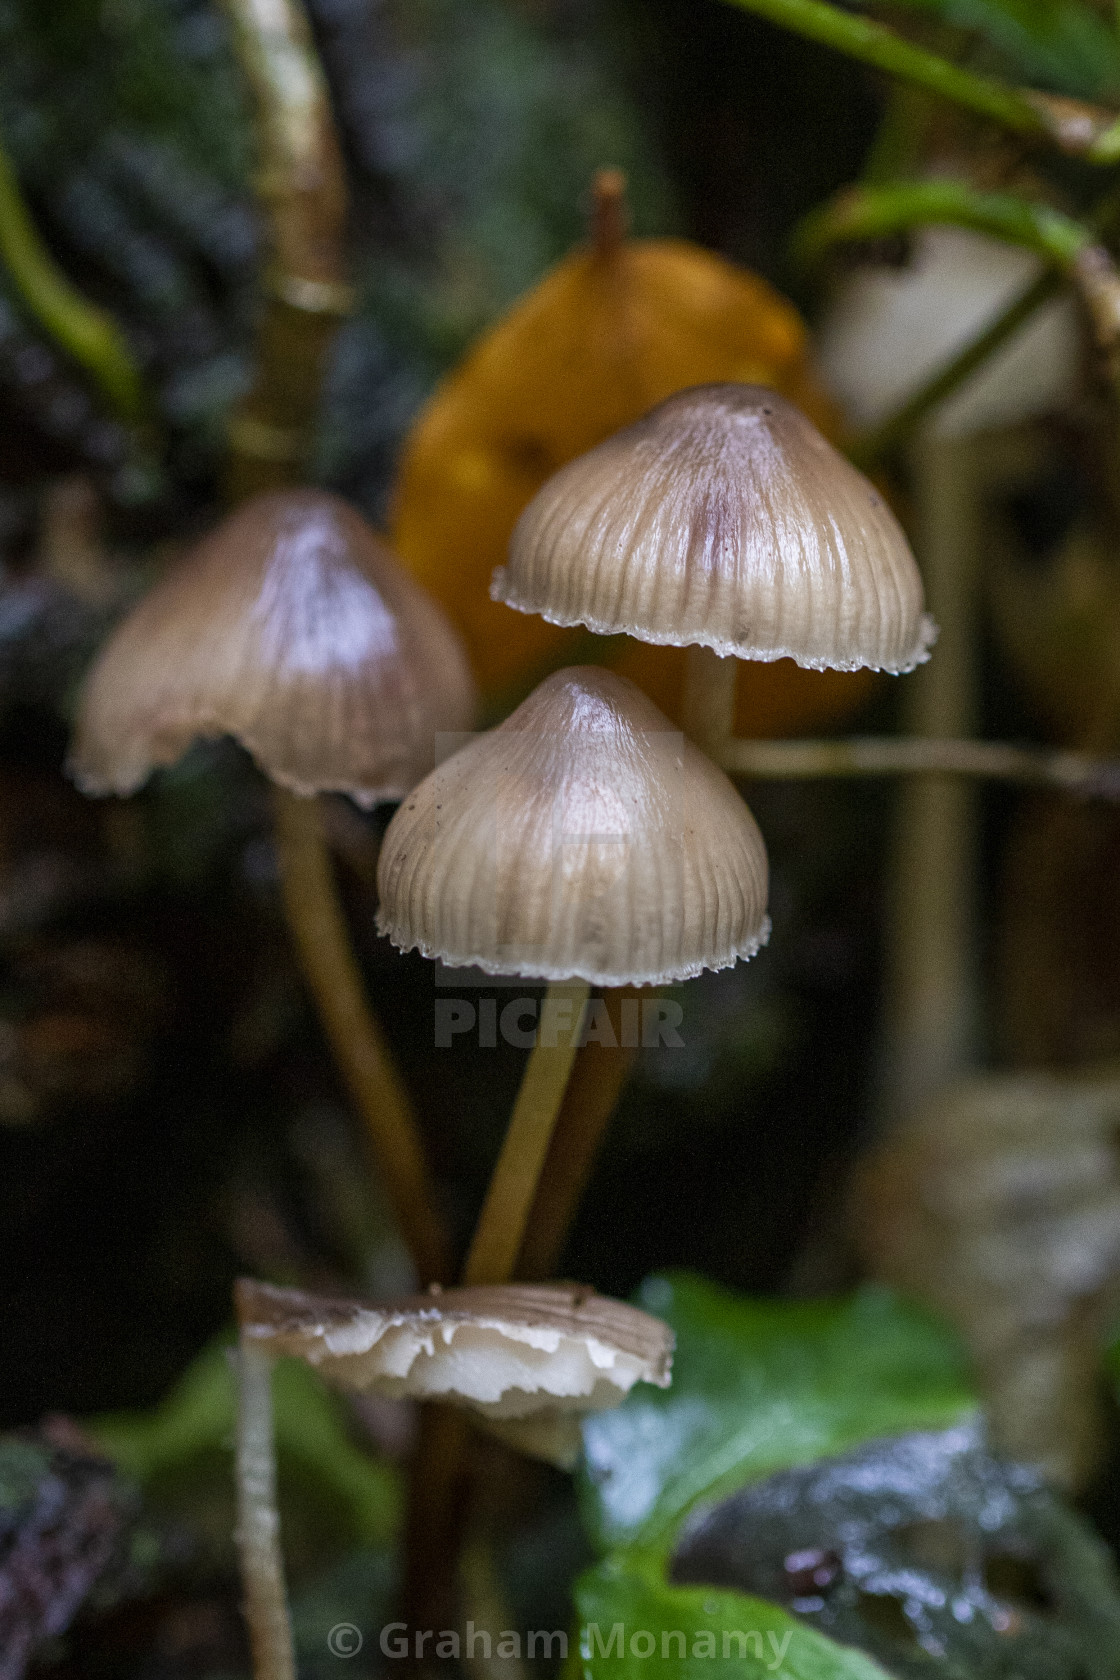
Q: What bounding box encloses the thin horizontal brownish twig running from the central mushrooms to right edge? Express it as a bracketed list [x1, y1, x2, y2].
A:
[712, 736, 1120, 800]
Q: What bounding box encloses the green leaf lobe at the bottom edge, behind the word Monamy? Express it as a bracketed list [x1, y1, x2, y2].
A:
[569, 1557, 885, 1680]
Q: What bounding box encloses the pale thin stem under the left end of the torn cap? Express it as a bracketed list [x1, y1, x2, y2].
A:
[237, 1336, 296, 1680]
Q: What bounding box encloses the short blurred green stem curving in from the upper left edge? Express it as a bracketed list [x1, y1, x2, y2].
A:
[0, 133, 148, 425]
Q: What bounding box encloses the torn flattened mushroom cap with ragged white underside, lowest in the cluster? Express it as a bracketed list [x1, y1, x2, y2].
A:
[237, 1278, 673, 1463]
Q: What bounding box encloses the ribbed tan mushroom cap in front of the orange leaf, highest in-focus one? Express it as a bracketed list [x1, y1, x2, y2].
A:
[490, 385, 935, 672]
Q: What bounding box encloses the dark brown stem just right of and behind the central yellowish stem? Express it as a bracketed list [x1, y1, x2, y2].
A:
[517, 986, 638, 1282]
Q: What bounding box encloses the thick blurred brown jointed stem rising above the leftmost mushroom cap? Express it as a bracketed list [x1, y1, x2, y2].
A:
[223, 0, 353, 502]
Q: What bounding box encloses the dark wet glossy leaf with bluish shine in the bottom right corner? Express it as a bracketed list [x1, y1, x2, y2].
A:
[668, 1421, 1120, 1680]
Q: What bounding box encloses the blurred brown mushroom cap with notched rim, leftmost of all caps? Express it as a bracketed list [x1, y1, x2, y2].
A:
[71, 491, 475, 805]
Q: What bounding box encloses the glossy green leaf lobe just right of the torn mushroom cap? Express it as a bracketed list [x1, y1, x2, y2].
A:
[584, 1273, 976, 1551]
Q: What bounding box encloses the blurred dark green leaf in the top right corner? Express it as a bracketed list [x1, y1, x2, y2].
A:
[873, 0, 1120, 99]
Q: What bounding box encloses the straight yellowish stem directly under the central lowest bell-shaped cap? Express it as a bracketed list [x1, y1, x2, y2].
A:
[463, 979, 589, 1284]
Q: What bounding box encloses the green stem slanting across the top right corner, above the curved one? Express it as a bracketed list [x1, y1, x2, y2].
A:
[727, 0, 1120, 165]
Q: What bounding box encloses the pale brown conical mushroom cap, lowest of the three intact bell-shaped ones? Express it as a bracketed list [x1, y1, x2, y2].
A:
[378, 667, 769, 986]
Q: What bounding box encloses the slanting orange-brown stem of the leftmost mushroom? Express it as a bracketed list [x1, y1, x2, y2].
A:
[274, 786, 450, 1284]
